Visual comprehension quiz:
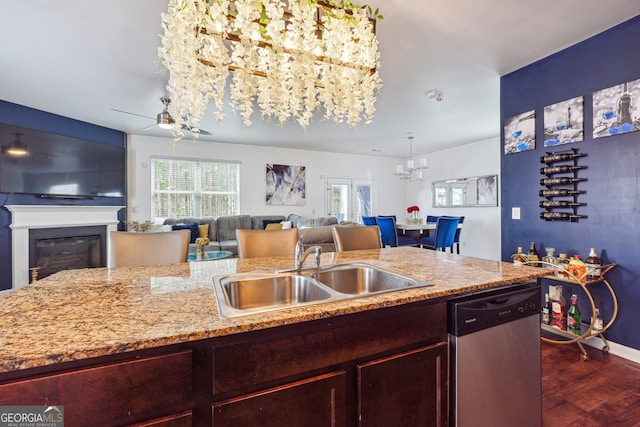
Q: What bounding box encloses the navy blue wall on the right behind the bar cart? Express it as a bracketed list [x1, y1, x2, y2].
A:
[500, 16, 640, 350]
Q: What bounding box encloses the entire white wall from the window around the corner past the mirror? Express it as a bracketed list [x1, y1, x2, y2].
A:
[128, 135, 500, 260]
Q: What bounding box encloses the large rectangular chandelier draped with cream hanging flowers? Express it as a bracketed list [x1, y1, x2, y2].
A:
[158, 0, 382, 136]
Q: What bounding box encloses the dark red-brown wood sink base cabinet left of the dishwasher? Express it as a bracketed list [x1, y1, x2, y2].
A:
[195, 303, 448, 427]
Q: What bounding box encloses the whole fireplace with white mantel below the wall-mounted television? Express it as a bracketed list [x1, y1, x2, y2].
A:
[5, 205, 123, 289]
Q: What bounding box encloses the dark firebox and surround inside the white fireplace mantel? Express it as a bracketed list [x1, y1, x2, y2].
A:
[29, 225, 107, 279]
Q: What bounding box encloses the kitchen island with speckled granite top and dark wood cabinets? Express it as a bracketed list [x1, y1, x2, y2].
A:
[0, 247, 548, 426]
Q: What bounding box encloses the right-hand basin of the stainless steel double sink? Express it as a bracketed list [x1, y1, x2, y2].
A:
[313, 264, 429, 295]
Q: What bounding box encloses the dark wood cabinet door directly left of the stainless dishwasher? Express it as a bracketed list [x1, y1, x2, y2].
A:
[358, 343, 448, 427]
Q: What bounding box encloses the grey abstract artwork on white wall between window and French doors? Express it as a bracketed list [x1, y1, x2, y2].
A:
[266, 164, 307, 206]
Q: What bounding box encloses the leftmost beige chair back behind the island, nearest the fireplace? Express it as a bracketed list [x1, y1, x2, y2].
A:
[107, 230, 191, 268]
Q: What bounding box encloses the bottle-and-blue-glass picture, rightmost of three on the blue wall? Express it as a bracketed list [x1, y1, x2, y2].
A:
[593, 79, 640, 138]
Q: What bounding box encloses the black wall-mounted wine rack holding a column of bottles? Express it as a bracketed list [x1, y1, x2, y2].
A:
[539, 148, 587, 222]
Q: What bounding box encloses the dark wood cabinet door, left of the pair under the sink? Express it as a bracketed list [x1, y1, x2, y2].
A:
[212, 371, 346, 427]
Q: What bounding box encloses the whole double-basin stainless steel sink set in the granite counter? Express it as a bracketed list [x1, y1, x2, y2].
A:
[214, 263, 431, 317]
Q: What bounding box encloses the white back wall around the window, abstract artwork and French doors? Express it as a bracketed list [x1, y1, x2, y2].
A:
[128, 135, 405, 220]
